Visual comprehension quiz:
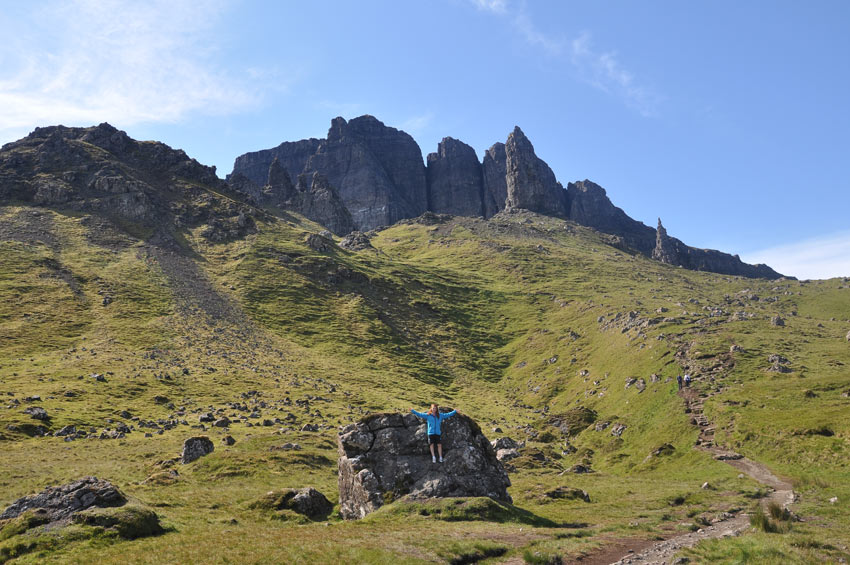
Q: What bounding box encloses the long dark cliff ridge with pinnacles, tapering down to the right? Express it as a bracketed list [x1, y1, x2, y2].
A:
[228, 116, 780, 278]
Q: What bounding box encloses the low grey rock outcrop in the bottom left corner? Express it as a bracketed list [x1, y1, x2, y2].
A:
[0, 477, 127, 522]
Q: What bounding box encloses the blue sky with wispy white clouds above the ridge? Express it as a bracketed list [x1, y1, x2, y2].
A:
[0, 0, 850, 278]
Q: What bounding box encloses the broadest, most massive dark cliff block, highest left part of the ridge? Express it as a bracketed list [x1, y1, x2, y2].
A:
[304, 116, 428, 231]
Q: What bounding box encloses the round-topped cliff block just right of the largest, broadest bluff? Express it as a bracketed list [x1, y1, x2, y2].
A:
[426, 137, 484, 216]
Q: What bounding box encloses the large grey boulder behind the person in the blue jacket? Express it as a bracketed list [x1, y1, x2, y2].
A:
[337, 414, 511, 519]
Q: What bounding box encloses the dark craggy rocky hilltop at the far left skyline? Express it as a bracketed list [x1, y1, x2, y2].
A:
[0, 123, 255, 239]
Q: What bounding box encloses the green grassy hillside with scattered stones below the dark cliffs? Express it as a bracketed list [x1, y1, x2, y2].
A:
[0, 206, 850, 563]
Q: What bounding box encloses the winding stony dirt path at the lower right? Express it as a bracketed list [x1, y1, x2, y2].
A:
[600, 388, 794, 565]
